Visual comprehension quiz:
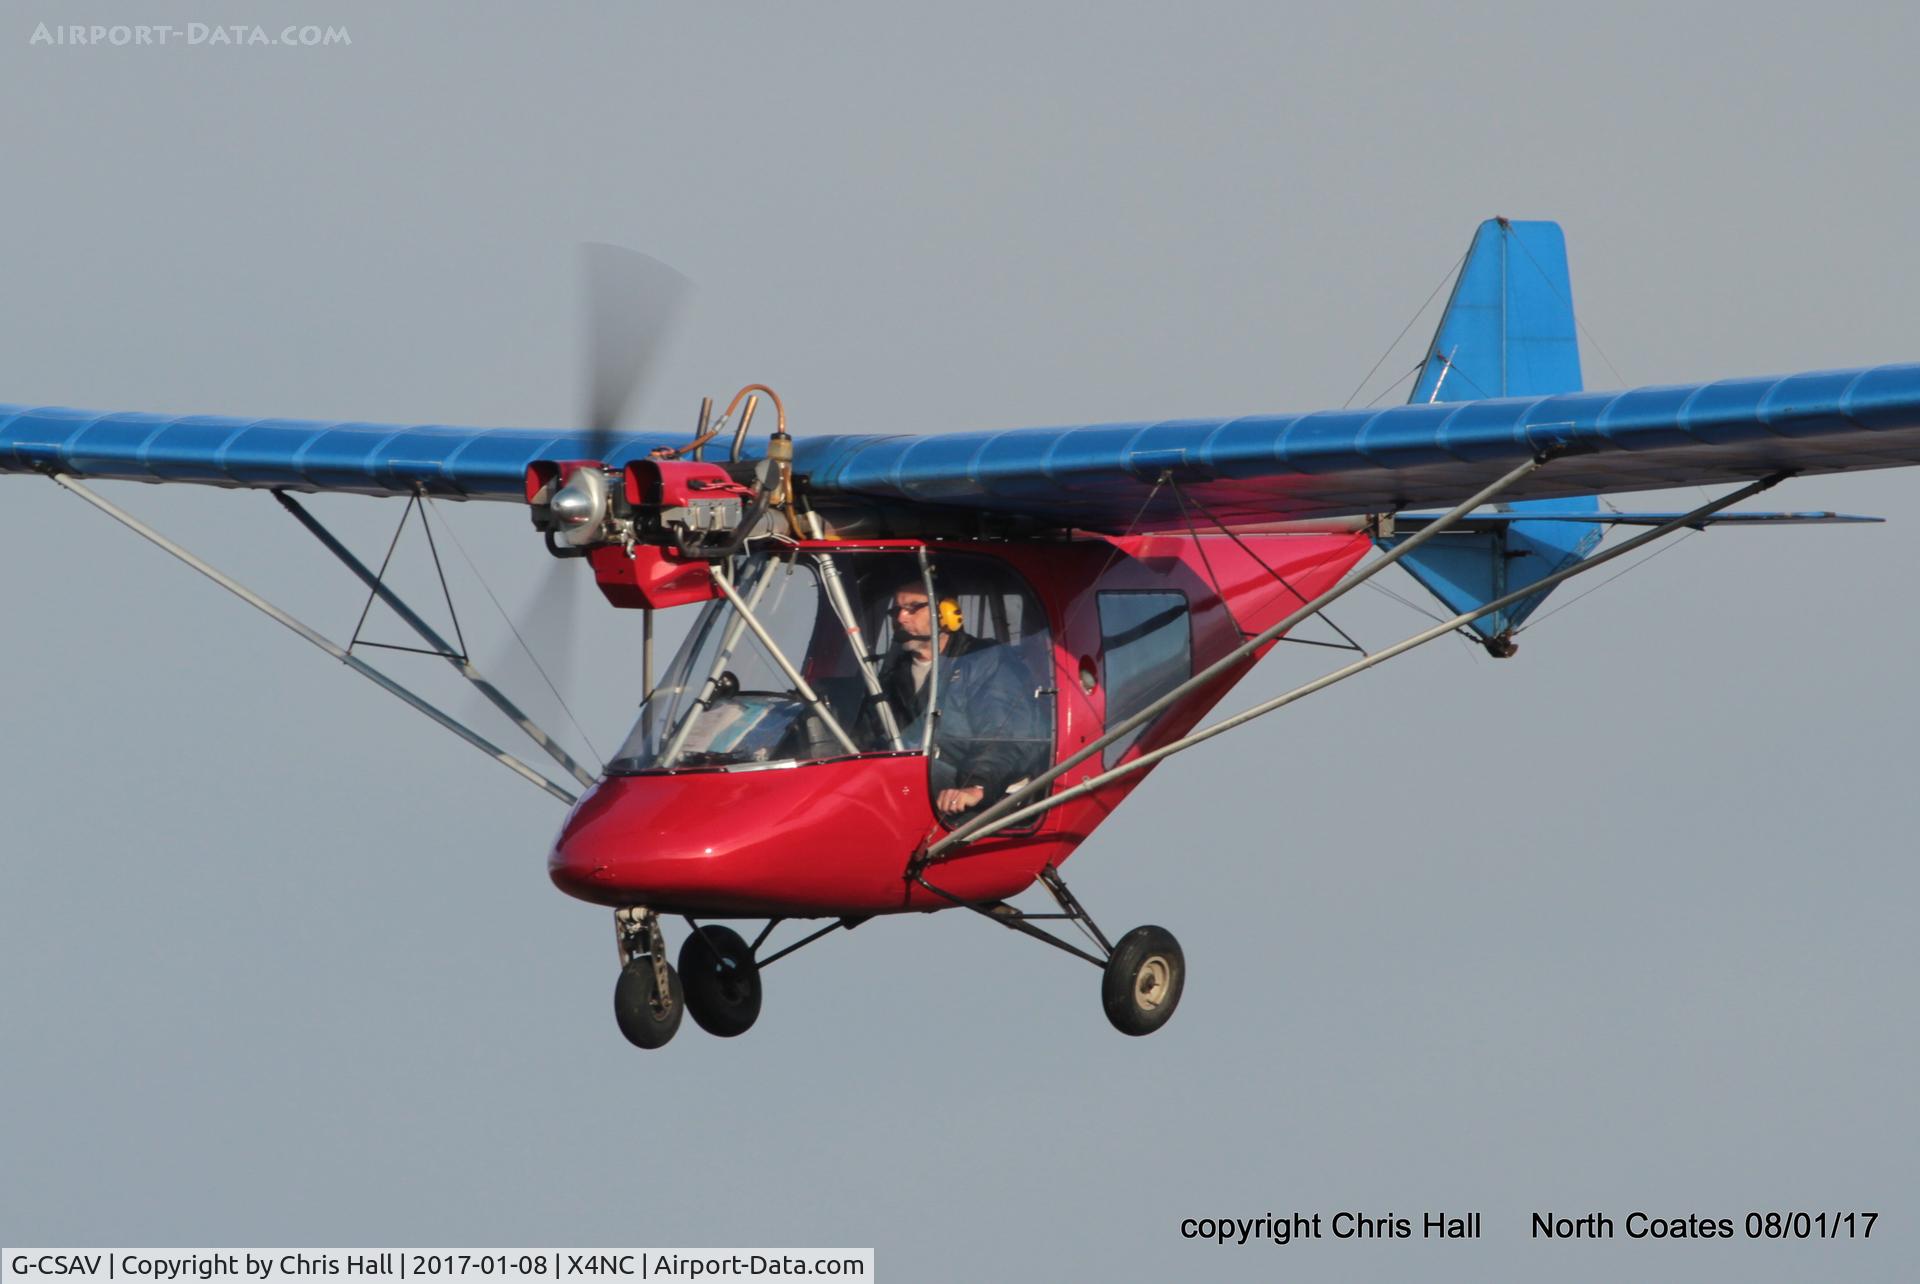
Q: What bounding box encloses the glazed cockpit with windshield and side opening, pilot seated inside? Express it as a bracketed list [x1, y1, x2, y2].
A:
[607, 549, 1054, 810]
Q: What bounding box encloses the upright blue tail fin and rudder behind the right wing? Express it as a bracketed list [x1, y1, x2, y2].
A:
[1388, 219, 1603, 656]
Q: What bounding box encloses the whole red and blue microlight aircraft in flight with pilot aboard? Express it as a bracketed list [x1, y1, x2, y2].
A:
[0, 219, 1920, 1048]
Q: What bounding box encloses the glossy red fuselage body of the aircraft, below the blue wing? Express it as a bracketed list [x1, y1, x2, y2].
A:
[549, 534, 1369, 917]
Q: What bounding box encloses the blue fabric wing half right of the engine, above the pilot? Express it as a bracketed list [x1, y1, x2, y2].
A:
[803, 365, 1920, 532]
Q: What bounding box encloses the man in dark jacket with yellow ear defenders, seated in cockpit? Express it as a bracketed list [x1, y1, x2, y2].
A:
[879, 580, 1048, 823]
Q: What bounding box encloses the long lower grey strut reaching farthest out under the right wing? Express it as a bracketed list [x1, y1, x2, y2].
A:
[908, 472, 1793, 852]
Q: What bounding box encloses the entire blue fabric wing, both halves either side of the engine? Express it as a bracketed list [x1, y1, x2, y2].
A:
[11, 365, 1920, 532]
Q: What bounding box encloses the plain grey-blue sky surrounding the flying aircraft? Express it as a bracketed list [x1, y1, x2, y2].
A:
[0, 0, 1920, 1280]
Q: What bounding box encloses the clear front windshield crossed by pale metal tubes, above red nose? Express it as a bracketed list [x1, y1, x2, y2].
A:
[607, 553, 924, 773]
